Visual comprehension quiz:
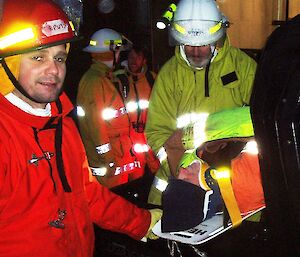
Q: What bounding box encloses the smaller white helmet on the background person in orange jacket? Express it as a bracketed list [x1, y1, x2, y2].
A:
[83, 28, 124, 53]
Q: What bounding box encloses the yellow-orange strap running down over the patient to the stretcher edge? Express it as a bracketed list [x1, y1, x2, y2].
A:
[215, 169, 242, 227]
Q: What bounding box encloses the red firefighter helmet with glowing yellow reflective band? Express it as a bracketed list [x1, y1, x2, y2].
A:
[0, 0, 77, 58]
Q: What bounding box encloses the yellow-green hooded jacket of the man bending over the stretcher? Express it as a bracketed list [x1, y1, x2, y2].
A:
[146, 38, 256, 204]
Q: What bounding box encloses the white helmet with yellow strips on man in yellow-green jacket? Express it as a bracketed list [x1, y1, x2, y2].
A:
[170, 0, 228, 46]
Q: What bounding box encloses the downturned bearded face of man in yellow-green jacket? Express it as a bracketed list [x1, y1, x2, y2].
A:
[184, 45, 212, 68]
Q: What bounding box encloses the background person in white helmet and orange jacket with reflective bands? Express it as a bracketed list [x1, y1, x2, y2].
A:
[77, 28, 159, 195]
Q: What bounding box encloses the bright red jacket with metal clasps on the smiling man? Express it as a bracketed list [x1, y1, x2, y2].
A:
[0, 94, 151, 257]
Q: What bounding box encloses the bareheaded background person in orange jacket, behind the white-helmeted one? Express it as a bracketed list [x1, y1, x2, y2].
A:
[113, 44, 160, 203]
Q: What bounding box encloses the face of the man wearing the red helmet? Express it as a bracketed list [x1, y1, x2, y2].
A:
[14, 45, 67, 108]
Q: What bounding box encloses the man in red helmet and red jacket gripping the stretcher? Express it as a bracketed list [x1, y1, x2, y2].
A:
[0, 0, 160, 257]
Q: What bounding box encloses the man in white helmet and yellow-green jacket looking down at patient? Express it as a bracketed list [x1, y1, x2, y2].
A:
[146, 0, 256, 205]
